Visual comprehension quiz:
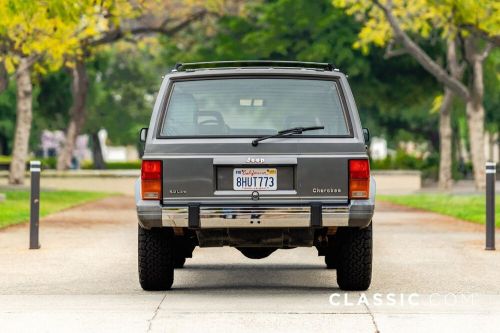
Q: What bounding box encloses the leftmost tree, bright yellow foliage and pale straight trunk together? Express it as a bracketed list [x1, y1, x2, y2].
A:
[0, 0, 82, 184]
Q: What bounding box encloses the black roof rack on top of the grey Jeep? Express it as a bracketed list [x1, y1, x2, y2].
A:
[172, 60, 336, 72]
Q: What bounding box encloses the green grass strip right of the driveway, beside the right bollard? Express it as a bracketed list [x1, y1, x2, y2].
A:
[377, 194, 500, 227]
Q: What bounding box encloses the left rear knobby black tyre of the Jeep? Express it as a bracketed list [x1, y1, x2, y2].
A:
[139, 226, 174, 290]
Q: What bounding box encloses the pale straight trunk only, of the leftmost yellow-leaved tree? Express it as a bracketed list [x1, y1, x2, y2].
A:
[9, 58, 33, 185]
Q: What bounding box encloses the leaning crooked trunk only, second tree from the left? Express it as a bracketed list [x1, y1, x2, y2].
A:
[57, 61, 89, 170]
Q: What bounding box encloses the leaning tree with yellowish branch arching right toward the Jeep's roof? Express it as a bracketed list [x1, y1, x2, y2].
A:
[57, 0, 213, 170]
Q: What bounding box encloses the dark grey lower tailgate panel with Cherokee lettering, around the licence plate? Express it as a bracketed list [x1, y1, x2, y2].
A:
[163, 155, 349, 203]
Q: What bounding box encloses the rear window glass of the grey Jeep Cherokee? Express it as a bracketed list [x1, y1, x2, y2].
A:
[160, 78, 350, 137]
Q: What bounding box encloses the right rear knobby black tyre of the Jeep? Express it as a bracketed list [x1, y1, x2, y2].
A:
[337, 223, 372, 290]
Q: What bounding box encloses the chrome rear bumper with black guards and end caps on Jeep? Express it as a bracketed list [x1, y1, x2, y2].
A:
[136, 177, 376, 229]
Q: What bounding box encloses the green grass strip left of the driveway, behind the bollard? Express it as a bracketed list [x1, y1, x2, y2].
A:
[0, 191, 112, 228]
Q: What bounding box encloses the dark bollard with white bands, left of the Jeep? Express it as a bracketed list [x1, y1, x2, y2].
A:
[30, 161, 41, 250]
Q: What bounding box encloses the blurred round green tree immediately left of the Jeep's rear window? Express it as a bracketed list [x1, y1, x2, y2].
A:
[84, 48, 158, 145]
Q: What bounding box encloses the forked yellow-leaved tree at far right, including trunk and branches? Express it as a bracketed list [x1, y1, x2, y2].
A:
[334, 0, 500, 188]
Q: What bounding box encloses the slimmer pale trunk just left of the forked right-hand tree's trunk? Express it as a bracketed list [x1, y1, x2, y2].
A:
[439, 88, 453, 190]
